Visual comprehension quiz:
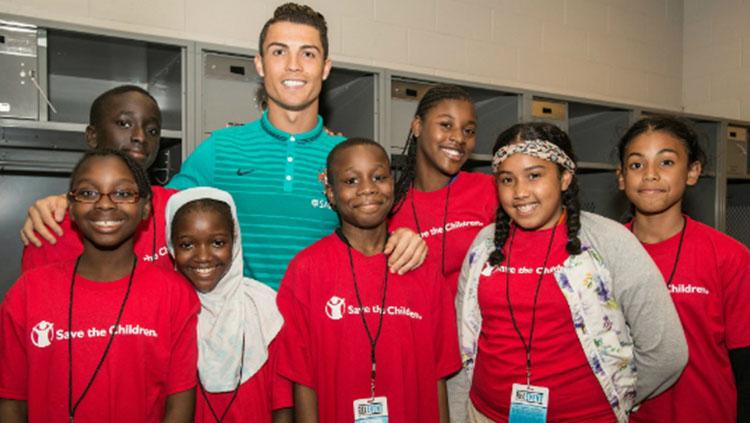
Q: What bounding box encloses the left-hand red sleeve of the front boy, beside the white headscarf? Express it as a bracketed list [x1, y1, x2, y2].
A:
[276, 260, 315, 389]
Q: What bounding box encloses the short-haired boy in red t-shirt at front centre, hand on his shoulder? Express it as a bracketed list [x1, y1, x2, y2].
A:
[277, 138, 460, 423]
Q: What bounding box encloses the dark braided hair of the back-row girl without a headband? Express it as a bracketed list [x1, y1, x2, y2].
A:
[391, 84, 474, 215]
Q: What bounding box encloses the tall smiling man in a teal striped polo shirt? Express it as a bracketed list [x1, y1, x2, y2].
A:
[168, 3, 423, 289]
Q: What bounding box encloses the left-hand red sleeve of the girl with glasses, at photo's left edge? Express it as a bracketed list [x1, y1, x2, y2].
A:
[0, 276, 29, 401]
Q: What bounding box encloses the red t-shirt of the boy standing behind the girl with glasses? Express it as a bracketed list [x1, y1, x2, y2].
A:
[21, 185, 177, 273]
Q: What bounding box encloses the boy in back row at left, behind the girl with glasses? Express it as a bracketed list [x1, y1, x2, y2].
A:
[21, 85, 175, 272]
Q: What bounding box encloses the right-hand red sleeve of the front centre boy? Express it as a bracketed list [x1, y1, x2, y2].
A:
[427, 272, 461, 379]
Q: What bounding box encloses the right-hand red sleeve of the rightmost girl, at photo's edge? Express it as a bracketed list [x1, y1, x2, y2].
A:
[719, 240, 750, 350]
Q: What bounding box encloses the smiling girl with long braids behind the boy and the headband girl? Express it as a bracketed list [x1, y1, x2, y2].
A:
[388, 84, 497, 298]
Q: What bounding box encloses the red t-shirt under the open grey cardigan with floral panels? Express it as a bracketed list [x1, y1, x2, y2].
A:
[470, 223, 615, 422]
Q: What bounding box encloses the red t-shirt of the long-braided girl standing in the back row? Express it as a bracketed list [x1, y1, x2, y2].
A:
[389, 172, 498, 298]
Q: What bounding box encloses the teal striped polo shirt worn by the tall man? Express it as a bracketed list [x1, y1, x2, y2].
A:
[167, 112, 344, 289]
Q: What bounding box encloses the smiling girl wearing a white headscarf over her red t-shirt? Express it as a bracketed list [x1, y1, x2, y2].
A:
[166, 187, 292, 423]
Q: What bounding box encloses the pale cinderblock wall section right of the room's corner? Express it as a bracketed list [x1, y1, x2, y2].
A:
[683, 0, 750, 120]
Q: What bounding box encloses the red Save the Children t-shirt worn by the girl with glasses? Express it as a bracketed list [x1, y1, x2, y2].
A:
[0, 261, 200, 422]
